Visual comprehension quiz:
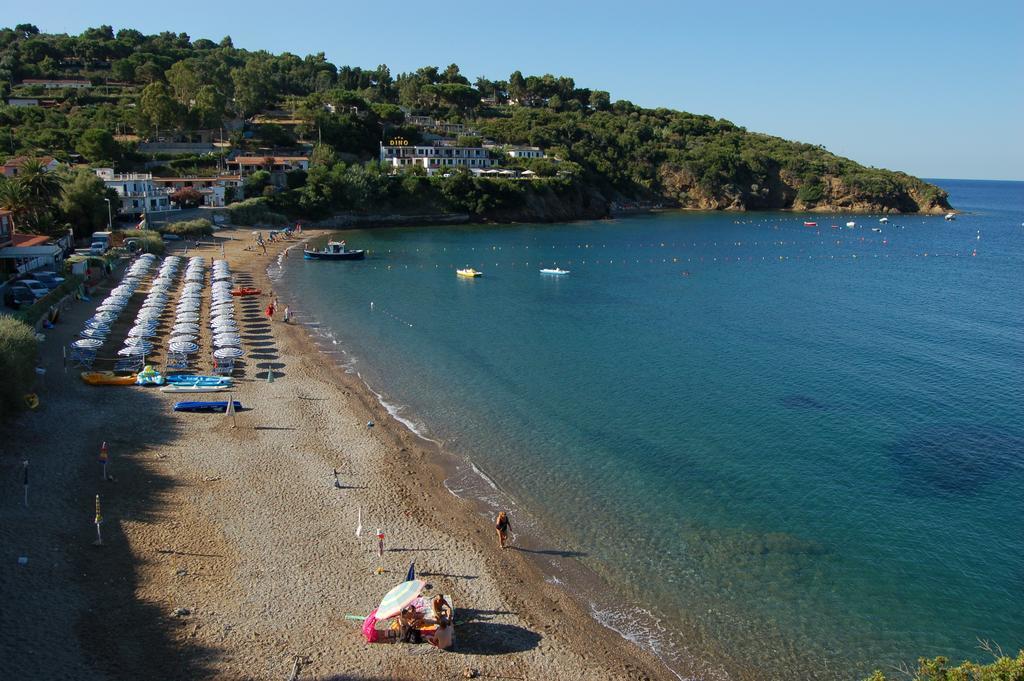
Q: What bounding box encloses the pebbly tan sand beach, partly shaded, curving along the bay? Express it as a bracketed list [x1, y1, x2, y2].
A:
[0, 229, 673, 680]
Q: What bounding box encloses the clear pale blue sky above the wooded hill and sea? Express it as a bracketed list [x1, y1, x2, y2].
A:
[16, 0, 1024, 179]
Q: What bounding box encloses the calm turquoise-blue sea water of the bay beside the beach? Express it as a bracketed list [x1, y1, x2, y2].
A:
[280, 180, 1024, 678]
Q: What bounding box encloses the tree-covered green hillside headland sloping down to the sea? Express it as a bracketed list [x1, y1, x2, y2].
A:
[0, 25, 949, 228]
